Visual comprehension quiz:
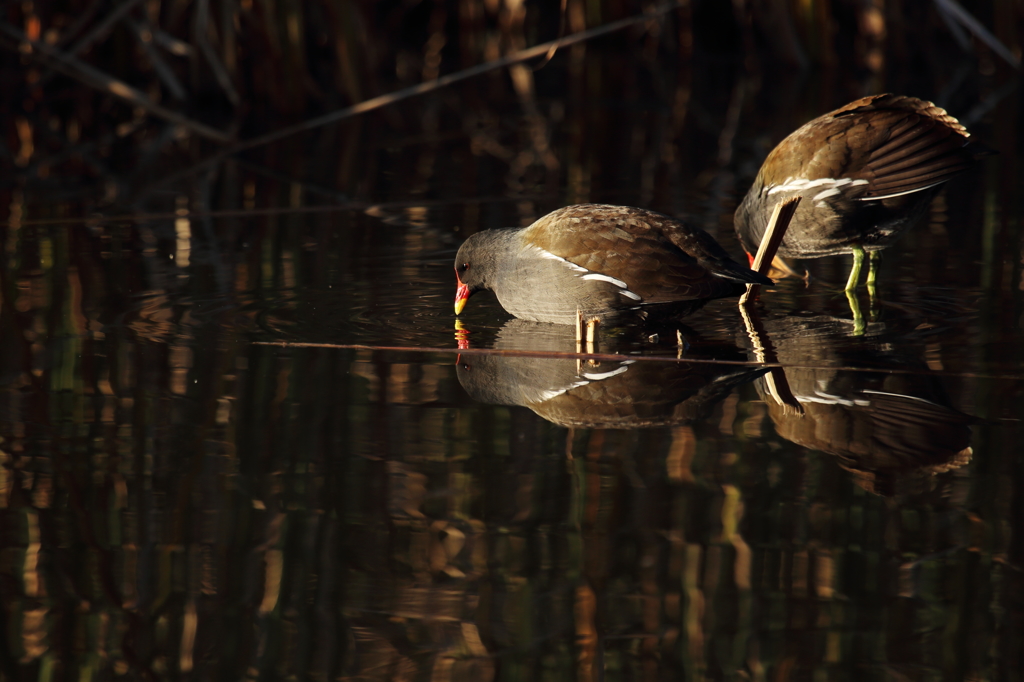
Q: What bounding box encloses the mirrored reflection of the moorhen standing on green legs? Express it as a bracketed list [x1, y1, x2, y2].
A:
[755, 316, 974, 494]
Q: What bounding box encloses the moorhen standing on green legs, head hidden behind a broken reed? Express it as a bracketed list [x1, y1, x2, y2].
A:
[735, 94, 991, 292]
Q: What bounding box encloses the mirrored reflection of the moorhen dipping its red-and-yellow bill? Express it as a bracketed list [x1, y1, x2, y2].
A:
[457, 321, 764, 428]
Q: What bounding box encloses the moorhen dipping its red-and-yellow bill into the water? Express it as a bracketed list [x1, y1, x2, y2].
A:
[455, 204, 773, 325]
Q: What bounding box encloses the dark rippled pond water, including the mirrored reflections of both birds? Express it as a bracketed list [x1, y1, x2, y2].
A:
[0, 26, 1024, 681]
